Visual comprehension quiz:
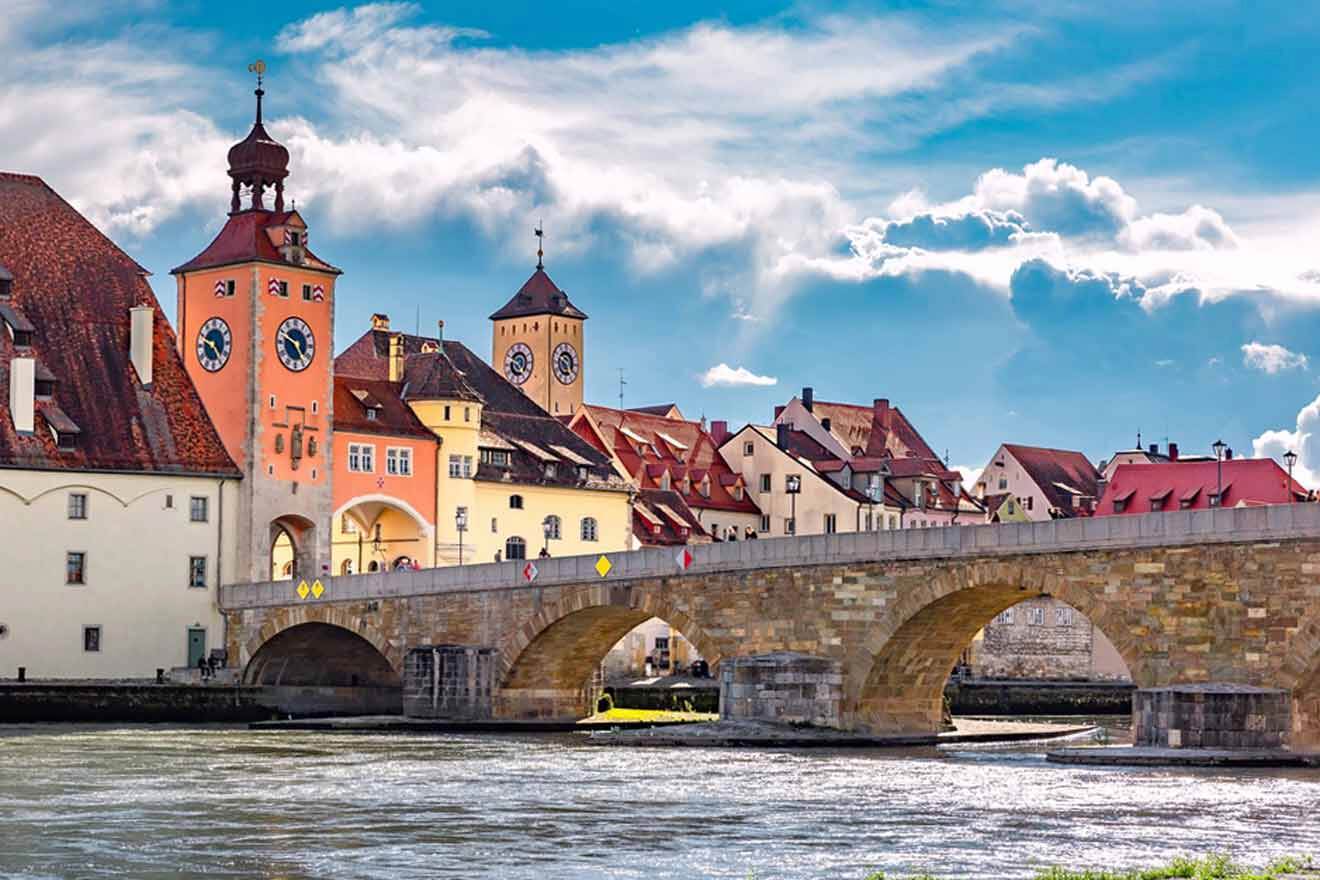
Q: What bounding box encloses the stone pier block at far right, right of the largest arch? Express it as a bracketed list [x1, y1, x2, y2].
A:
[1133, 683, 1292, 749]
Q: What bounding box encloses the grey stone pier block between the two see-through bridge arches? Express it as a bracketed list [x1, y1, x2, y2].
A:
[719, 652, 843, 727]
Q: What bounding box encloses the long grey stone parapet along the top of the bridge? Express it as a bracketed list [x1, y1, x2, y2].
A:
[220, 504, 1320, 610]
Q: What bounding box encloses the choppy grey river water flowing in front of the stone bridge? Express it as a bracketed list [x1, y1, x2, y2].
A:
[0, 726, 1320, 880]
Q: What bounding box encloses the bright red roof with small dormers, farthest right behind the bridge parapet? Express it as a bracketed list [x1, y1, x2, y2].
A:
[1096, 458, 1307, 516]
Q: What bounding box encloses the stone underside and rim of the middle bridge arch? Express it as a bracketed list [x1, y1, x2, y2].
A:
[496, 586, 727, 718]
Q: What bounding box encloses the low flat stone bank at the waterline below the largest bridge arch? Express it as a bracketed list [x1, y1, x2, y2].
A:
[587, 718, 1097, 748]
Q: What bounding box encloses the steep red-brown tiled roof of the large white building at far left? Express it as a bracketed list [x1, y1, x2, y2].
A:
[0, 173, 239, 476]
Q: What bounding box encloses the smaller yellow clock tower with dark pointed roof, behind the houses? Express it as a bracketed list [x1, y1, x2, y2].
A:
[491, 236, 586, 416]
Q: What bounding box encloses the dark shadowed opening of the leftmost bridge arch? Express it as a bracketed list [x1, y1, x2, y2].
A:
[243, 620, 403, 715]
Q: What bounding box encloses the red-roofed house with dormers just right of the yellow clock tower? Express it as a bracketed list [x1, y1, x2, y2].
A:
[569, 404, 760, 546]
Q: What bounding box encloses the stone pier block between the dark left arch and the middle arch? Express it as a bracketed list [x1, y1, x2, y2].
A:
[404, 645, 499, 720]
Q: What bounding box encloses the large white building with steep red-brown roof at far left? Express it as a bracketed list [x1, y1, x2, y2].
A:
[0, 174, 240, 678]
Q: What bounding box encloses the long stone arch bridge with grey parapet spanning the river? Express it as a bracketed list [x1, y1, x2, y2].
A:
[222, 504, 1320, 743]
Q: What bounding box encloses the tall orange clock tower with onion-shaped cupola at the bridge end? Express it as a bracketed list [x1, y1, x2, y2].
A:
[172, 62, 339, 581]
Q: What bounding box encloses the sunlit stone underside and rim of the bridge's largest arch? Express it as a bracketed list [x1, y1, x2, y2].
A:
[845, 562, 1156, 734]
